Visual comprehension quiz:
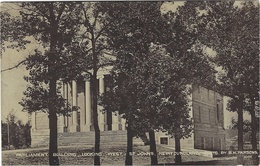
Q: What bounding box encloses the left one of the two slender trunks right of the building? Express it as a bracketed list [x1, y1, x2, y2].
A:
[237, 98, 244, 164]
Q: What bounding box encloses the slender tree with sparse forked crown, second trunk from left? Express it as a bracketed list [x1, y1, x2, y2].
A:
[69, 2, 120, 165]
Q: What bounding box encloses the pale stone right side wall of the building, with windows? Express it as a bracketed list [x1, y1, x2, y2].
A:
[192, 87, 225, 150]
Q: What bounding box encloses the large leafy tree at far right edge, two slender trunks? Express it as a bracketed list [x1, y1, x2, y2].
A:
[196, 1, 259, 163]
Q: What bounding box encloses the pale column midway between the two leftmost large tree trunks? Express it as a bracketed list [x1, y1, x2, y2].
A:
[70, 80, 78, 132]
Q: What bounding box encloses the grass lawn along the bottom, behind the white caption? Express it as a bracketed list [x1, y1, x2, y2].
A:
[2, 146, 258, 165]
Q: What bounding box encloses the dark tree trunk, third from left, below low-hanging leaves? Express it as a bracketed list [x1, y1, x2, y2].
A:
[125, 122, 133, 165]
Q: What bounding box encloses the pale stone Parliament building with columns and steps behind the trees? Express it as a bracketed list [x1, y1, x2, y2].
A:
[30, 68, 225, 150]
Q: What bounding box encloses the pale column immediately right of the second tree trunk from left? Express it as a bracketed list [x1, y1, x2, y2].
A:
[98, 76, 106, 131]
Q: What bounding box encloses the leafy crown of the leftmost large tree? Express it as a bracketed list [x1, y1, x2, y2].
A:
[14, 2, 85, 114]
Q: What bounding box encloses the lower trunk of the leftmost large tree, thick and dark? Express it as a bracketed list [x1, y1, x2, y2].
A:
[49, 79, 59, 165]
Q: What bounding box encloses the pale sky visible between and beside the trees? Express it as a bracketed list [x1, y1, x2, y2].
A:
[1, 2, 248, 127]
